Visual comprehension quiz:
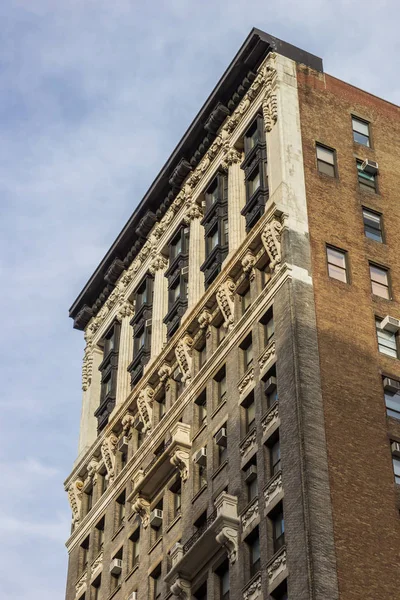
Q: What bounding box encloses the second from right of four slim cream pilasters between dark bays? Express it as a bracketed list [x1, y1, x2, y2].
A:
[185, 203, 205, 309]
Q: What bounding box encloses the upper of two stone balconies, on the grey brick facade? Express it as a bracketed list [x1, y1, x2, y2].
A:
[128, 423, 192, 502]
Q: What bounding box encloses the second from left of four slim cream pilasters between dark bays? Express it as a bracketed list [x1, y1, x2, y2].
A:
[150, 255, 168, 360]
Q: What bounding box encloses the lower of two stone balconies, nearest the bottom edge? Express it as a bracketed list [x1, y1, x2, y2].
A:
[165, 492, 240, 597]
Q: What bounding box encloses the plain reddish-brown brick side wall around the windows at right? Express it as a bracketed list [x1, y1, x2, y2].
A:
[298, 67, 400, 600]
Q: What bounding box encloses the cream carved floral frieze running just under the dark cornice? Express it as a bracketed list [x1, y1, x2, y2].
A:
[79, 53, 278, 340]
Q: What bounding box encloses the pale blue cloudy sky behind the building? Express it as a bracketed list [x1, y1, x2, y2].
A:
[0, 0, 400, 600]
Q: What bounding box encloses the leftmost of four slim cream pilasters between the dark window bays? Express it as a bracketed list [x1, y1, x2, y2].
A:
[116, 302, 133, 405]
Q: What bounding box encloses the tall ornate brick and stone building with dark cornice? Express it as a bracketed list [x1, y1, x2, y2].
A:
[65, 30, 400, 600]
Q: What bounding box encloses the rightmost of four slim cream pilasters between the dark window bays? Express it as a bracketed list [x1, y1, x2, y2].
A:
[222, 148, 246, 256]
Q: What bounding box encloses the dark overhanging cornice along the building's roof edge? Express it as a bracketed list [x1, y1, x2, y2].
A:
[69, 28, 323, 329]
